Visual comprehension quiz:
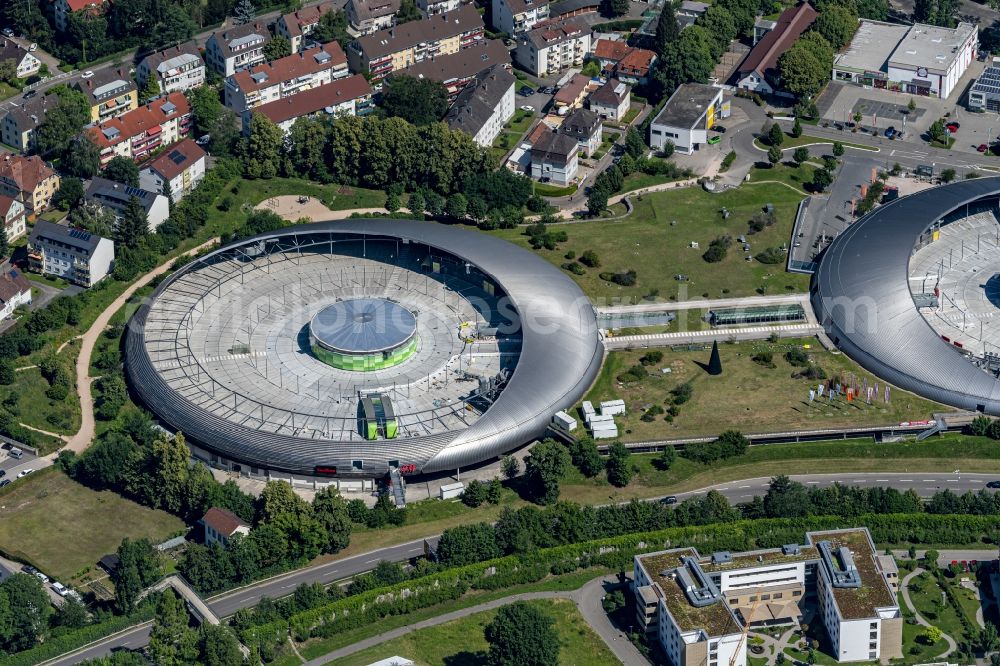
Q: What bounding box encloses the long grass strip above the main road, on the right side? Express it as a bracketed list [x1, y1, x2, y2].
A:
[560, 435, 1000, 503]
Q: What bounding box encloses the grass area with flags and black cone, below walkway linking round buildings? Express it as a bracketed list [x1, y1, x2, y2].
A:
[587, 338, 948, 441]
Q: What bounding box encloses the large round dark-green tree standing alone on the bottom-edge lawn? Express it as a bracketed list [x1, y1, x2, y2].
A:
[484, 601, 559, 666]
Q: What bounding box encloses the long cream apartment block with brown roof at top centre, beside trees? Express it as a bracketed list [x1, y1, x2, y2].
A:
[347, 5, 485, 81]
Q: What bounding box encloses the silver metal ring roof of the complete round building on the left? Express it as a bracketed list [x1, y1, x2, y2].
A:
[125, 219, 604, 476]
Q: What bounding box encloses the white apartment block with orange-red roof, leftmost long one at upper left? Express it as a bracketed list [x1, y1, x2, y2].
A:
[87, 92, 192, 166]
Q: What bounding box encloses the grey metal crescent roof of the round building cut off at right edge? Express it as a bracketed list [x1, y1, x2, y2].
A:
[812, 177, 1000, 415]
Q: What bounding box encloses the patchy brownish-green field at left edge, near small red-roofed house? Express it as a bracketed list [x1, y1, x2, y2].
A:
[0, 467, 184, 582]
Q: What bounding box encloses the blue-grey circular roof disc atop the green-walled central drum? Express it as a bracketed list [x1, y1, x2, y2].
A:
[309, 298, 417, 354]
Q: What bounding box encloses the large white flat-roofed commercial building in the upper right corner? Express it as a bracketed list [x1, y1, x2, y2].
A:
[833, 20, 979, 99]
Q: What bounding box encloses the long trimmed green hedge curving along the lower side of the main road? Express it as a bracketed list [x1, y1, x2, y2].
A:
[243, 514, 1000, 654]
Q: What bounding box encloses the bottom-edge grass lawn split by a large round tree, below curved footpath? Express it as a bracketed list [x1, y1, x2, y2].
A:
[333, 599, 616, 666]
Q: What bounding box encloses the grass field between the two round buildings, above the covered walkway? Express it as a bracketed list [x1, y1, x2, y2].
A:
[495, 179, 809, 304]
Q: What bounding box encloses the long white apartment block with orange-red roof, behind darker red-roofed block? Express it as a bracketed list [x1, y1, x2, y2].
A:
[225, 42, 350, 116]
